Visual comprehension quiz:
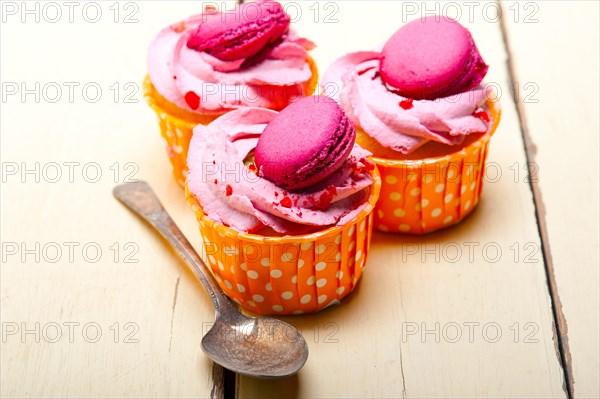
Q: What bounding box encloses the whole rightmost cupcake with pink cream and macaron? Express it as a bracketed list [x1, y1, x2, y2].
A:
[322, 16, 500, 234]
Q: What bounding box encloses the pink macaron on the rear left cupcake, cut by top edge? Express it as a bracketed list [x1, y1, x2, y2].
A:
[187, 0, 290, 61]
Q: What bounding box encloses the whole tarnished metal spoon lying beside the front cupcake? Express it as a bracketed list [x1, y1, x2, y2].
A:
[113, 181, 308, 378]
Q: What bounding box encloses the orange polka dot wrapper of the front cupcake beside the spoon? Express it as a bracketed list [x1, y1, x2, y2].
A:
[186, 170, 381, 315]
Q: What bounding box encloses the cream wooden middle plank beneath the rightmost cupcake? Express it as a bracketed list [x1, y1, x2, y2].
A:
[237, 1, 566, 398]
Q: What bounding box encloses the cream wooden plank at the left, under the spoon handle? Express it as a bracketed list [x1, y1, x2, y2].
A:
[0, 1, 240, 398]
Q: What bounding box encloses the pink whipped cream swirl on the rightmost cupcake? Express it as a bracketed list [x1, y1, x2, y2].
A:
[321, 51, 490, 154]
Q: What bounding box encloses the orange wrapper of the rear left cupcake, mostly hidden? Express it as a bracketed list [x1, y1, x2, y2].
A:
[144, 58, 318, 187]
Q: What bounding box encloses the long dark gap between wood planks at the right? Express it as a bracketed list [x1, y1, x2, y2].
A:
[497, 1, 575, 399]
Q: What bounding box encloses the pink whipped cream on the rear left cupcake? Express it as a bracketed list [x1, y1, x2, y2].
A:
[147, 11, 315, 114]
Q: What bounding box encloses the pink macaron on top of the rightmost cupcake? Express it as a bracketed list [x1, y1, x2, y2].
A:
[380, 15, 488, 100]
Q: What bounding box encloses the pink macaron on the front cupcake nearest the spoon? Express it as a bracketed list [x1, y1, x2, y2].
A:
[254, 96, 356, 190]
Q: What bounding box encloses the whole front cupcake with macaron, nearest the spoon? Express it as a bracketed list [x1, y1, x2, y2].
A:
[186, 96, 380, 314]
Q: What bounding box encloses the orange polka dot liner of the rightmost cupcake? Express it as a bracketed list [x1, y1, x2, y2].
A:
[371, 101, 501, 234]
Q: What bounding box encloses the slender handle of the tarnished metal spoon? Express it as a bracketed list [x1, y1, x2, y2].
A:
[113, 181, 232, 314]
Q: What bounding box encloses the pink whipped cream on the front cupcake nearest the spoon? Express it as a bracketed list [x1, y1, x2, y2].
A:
[187, 107, 374, 234]
